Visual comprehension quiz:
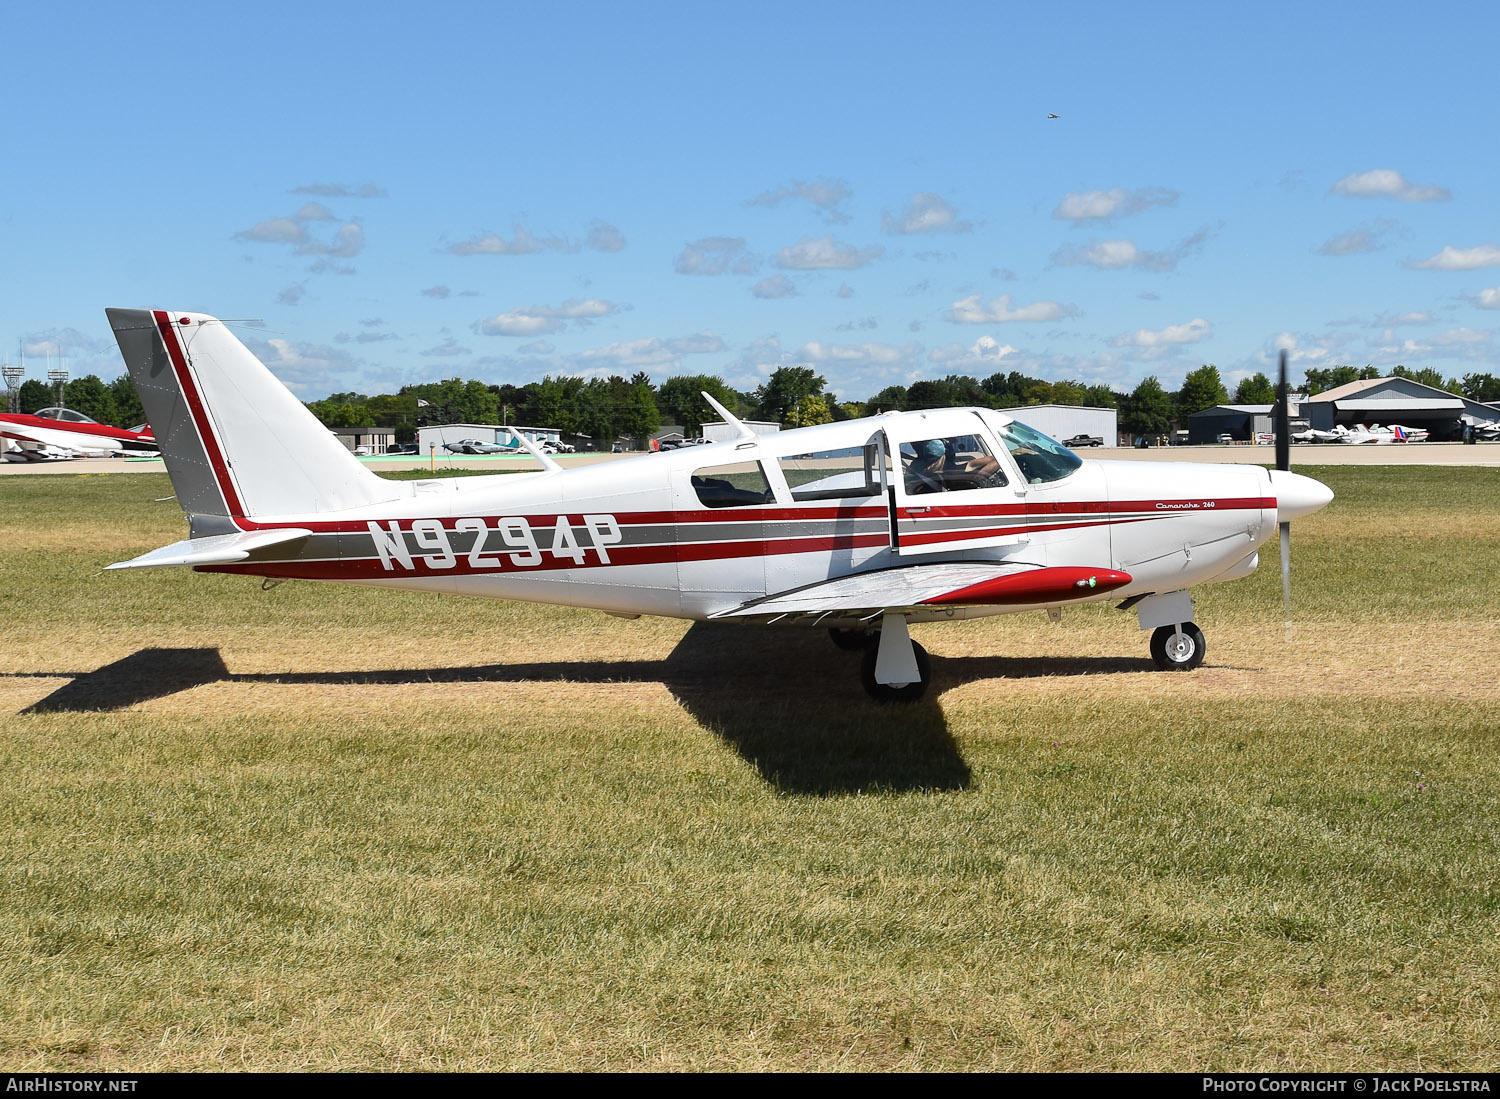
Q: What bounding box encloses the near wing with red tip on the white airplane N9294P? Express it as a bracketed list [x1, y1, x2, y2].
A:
[713, 561, 1131, 619]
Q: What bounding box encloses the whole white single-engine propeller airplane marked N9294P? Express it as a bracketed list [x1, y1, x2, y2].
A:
[99, 309, 1332, 700]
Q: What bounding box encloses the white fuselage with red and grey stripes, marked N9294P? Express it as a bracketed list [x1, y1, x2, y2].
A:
[194, 409, 1296, 621]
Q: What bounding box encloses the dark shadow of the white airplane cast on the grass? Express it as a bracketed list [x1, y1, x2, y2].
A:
[11, 622, 1152, 795]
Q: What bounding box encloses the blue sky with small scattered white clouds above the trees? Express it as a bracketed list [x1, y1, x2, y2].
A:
[0, 3, 1500, 399]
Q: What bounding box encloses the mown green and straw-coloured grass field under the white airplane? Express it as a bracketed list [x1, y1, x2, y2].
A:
[0, 468, 1500, 1071]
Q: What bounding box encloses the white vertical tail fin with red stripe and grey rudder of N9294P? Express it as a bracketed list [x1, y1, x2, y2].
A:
[105, 309, 401, 517]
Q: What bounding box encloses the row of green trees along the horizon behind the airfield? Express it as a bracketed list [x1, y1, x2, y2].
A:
[20, 364, 1500, 445]
